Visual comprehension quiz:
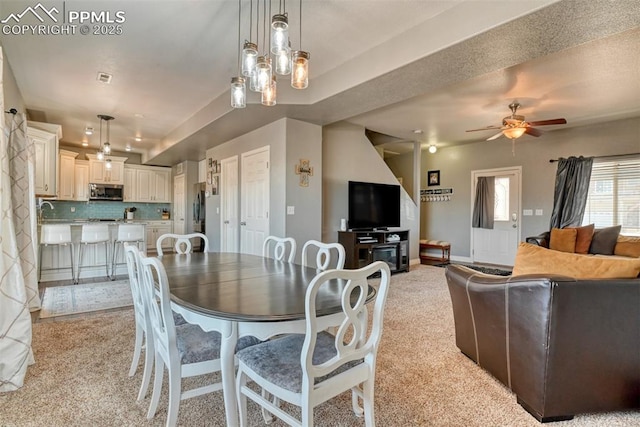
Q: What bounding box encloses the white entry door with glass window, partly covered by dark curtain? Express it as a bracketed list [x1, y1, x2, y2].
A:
[471, 167, 522, 266]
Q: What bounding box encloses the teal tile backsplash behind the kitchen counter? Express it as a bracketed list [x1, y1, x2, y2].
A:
[42, 200, 171, 220]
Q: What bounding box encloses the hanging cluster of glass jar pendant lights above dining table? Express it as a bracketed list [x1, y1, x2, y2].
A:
[231, 0, 310, 108]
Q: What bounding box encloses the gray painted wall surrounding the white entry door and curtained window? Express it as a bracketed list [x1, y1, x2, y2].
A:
[416, 118, 640, 259]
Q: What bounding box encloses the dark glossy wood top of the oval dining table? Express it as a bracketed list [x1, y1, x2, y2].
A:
[159, 252, 375, 322]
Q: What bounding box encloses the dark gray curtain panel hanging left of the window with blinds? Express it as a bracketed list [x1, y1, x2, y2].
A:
[549, 156, 593, 229]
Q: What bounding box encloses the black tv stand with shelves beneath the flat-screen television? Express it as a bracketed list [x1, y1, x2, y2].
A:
[338, 229, 409, 273]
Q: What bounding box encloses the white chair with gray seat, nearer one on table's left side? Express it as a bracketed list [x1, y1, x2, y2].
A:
[140, 253, 260, 426]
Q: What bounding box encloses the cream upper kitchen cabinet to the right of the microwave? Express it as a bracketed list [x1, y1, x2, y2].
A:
[124, 165, 171, 203]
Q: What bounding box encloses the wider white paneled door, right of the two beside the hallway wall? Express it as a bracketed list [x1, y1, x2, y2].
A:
[240, 146, 269, 255]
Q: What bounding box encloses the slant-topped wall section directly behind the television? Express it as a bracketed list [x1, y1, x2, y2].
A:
[322, 122, 420, 260]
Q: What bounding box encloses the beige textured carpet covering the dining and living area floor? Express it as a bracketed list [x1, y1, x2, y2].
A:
[0, 266, 640, 427]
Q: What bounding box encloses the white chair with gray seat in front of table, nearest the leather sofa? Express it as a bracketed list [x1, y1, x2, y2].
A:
[236, 261, 390, 427]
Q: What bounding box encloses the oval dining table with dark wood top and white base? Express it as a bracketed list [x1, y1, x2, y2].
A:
[158, 252, 375, 426]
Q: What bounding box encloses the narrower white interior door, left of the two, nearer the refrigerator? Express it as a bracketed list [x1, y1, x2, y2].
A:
[220, 156, 240, 252]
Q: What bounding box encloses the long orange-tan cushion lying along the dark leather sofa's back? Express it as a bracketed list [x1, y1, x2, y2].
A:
[512, 242, 640, 279]
